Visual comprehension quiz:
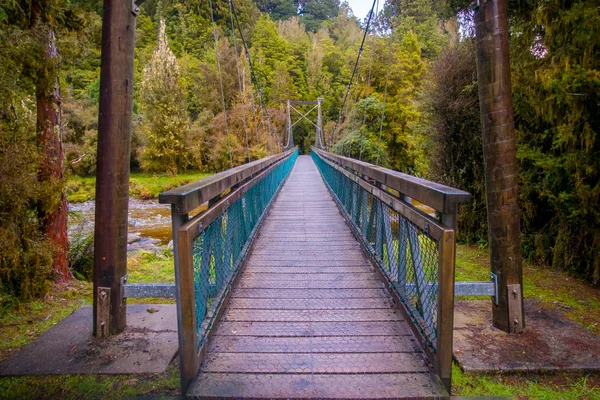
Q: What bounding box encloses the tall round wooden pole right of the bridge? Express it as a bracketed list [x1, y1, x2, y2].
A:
[475, 0, 525, 332]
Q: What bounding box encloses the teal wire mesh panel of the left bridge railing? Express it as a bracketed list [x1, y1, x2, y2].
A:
[193, 150, 298, 346]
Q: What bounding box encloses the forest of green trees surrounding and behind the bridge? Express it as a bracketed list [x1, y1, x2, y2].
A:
[0, 0, 600, 298]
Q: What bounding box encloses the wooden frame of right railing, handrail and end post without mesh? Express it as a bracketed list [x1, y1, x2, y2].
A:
[311, 147, 471, 391]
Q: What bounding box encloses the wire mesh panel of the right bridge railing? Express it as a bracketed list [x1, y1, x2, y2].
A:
[311, 152, 440, 352]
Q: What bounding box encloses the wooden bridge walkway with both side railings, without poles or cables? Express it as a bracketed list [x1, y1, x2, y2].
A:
[160, 130, 469, 398]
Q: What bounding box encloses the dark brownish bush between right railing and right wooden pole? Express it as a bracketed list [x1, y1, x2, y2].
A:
[422, 40, 487, 242]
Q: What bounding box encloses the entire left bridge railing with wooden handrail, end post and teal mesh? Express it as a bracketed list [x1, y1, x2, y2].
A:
[161, 148, 298, 392]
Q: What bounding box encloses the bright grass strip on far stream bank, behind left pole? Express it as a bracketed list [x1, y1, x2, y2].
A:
[67, 171, 211, 203]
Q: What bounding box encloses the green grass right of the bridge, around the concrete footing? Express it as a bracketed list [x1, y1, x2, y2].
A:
[452, 245, 600, 399]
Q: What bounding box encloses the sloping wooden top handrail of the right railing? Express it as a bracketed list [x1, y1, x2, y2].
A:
[311, 147, 471, 214]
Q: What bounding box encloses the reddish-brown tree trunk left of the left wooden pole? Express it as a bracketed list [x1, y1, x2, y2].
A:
[36, 30, 72, 281]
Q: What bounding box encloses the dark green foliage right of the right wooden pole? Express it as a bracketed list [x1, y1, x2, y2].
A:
[511, 1, 600, 283]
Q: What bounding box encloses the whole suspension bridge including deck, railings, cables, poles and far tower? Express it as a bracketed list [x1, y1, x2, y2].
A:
[83, 0, 523, 398]
